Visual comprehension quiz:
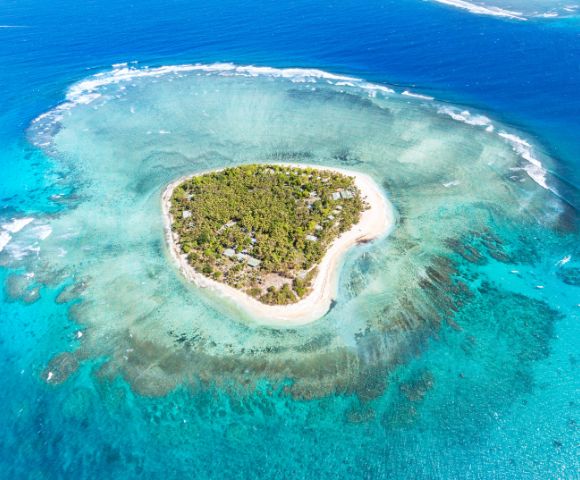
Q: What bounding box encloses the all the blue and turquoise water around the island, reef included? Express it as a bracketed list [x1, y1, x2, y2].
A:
[0, 0, 580, 479]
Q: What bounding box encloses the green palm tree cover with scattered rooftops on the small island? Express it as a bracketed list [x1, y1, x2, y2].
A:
[171, 165, 365, 304]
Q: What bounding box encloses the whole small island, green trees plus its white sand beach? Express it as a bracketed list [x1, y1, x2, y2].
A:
[162, 163, 393, 324]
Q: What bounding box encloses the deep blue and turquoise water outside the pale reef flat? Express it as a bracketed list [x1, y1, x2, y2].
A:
[0, 0, 580, 479]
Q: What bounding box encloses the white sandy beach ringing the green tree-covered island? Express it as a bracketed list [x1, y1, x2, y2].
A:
[161, 162, 395, 326]
